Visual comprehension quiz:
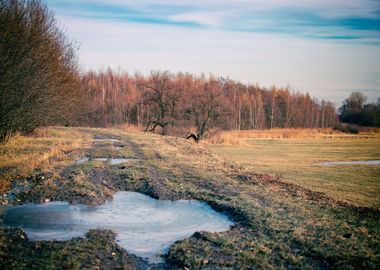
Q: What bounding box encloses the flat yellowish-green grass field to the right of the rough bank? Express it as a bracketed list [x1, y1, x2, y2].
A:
[207, 133, 380, 209]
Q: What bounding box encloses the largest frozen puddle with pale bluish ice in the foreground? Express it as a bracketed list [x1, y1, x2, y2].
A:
[3, 191, 233, 263]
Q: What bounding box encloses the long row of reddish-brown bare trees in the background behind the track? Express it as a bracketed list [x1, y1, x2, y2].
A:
[82, 69, 338, 138]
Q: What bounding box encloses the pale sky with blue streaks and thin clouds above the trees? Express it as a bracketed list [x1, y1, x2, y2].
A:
[45, 0, 380, 106]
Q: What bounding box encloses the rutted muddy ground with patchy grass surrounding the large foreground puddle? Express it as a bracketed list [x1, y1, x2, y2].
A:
[0, 129, 380, 269]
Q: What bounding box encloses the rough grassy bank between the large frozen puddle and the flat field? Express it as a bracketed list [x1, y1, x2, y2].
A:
[119, 134, 380, 269]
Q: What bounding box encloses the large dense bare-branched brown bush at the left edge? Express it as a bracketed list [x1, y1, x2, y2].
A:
[0, 0, 80, 141]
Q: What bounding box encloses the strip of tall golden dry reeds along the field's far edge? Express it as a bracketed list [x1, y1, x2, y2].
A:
[206, 128, 380, 145]
